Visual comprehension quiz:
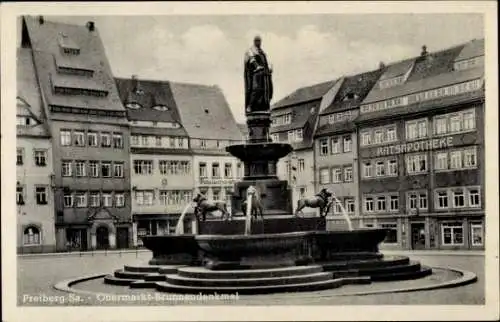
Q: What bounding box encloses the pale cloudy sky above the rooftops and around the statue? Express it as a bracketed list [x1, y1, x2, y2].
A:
[29, 14, 484, 122]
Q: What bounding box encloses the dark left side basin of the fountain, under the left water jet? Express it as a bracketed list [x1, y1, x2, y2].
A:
[141, 234, 198, 265]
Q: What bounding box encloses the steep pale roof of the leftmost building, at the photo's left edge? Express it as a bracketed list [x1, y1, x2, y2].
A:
[16, 48, 49, 136]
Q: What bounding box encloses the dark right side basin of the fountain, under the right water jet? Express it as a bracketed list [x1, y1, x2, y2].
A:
[309, 229, 387, 260]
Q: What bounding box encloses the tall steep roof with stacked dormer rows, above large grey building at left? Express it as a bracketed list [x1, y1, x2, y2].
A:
[22, 16, 125, 111]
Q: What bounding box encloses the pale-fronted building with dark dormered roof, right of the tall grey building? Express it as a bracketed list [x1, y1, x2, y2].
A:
[116, 76, 194, 245]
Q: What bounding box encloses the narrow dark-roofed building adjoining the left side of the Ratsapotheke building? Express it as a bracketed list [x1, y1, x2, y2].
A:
[314, 66, 383, 230]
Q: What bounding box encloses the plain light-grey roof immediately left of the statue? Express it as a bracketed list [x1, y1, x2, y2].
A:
[169, 82, 243, 141]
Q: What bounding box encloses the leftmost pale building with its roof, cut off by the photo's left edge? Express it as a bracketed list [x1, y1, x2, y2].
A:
[16, 48, 56, 253]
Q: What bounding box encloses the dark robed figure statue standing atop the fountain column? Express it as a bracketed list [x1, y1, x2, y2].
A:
[245, 36, 273, 113]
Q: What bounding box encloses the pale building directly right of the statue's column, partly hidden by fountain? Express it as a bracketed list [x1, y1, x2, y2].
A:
[270, 81, 336, 216]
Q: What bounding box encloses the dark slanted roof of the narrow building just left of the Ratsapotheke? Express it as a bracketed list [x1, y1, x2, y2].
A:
[321, 69, 384, 115]
